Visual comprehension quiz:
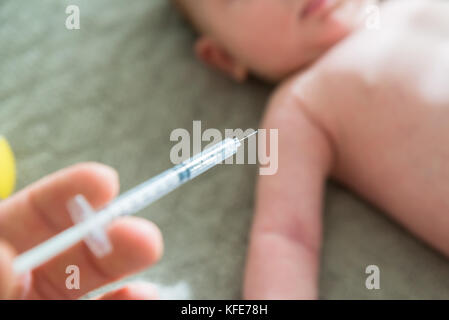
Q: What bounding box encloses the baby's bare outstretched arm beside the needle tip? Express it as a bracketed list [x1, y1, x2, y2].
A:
[244, 80, 332, 299]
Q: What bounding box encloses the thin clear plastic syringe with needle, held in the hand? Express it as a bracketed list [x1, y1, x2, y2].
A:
[13, 132, 257, 274]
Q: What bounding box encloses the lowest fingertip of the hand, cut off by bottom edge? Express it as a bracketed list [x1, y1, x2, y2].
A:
[96, 282, 159, 300]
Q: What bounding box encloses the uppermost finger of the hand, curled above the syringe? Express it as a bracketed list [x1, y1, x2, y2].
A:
[0, 163, 119, 253]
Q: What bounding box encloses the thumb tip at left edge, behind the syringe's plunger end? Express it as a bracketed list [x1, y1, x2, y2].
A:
[0, 241, 15, 299]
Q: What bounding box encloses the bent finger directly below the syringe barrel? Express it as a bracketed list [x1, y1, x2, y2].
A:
[24, 217, 163, 299]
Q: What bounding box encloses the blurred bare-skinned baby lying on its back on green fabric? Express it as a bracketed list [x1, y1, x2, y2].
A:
[173, 0, 449, 299]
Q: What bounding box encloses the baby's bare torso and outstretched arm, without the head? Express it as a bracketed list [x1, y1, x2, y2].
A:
[244, 1, 449, 299]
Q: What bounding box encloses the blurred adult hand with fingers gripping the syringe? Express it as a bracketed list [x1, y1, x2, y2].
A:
[0, 163, 163, 299]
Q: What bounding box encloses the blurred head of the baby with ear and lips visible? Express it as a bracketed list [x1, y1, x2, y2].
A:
[175, 0, 350, 81]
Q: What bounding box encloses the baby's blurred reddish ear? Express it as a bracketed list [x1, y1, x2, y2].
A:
[195, 36, 248, 82]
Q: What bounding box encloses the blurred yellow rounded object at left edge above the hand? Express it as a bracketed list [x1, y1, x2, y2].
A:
[0, 136, 16, 199]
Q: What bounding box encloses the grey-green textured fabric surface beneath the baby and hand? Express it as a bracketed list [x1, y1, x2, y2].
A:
[0, 0, 449, 299]
